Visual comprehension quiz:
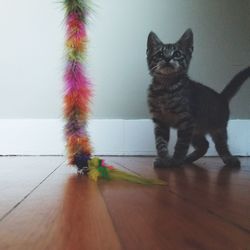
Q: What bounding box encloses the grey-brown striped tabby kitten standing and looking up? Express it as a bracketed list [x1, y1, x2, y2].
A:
[147, 29, 250, 167]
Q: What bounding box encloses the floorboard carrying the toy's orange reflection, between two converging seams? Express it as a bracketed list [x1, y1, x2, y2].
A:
[0, 162, 121, 250]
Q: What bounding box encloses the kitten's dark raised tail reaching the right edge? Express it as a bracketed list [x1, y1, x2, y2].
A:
[221, 66, 250, 101]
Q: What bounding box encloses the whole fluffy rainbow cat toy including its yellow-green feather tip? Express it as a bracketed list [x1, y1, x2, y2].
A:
[64, 0, 165, 185]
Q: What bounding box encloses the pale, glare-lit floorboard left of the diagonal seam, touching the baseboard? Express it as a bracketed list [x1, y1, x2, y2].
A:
[0, 156, 64, 219]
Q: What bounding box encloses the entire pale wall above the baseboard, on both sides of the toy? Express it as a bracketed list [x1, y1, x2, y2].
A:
[0, 0, 250, 119]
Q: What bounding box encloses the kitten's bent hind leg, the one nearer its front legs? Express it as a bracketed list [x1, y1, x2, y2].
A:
[184, 134, 209, 163]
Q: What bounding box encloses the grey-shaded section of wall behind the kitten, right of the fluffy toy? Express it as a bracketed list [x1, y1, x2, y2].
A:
[89, 0, 250, 118]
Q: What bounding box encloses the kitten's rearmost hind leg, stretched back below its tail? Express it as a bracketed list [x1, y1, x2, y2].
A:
[211, 128, 240, 168]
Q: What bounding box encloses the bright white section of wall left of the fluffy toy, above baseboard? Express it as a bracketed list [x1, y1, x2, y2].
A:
[0, 0, 64, 118]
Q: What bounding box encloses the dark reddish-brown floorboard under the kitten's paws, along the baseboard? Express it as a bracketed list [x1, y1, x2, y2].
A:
[112, 158, 250, 232]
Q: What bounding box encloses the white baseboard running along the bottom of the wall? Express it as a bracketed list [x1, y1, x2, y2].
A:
[0, 119, 250, 156]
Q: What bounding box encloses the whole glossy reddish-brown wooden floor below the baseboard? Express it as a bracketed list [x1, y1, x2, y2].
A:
[0, 157, 250, 250]
